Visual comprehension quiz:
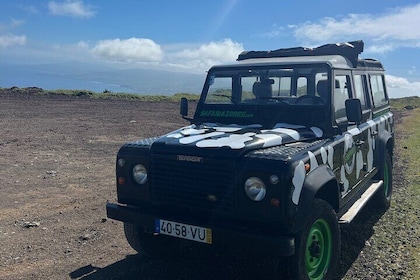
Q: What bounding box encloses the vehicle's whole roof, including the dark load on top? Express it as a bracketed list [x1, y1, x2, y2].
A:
[230, 40, 384, 71]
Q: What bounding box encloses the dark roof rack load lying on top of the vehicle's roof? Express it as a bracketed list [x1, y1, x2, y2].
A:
[237, 40, 364, 67]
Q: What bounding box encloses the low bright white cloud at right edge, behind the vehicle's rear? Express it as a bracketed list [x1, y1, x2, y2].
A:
[385, 75, 420, 98]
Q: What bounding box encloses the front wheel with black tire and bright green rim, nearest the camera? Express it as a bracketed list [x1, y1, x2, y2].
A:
[289, 199, 341, 280]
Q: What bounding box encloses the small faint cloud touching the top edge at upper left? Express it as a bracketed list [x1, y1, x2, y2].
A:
[48, 0, 95, 18]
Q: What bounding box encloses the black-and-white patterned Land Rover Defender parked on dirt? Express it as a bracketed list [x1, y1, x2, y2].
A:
[107, 41, 394, 279]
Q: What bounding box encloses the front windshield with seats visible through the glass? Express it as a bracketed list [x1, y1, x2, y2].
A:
[204, 67, 329, 106]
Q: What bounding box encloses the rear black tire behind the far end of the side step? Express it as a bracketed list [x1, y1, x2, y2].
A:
[374, 150, 392, 209]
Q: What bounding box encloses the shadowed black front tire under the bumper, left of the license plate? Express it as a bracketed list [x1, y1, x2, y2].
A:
[124, 223, 179, 259]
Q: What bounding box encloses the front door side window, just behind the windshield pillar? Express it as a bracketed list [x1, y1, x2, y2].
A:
[333, 75, 350, 120]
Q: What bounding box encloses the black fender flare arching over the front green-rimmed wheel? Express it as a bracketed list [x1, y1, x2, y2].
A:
[293, 164, 340, 232]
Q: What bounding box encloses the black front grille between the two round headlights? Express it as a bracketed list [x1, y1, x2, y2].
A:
[150, 154, 235, 211]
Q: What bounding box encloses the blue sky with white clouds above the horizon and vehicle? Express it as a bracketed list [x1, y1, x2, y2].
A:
[0, 0, 420, 96]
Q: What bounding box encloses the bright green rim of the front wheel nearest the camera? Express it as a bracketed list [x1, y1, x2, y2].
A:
[305, 219, 333, 280]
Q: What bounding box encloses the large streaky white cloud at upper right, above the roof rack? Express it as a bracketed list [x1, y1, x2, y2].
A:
[290, 4, 420, 52]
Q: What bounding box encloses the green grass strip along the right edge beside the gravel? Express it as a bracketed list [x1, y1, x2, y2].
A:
[398, 107, 420, 279]
